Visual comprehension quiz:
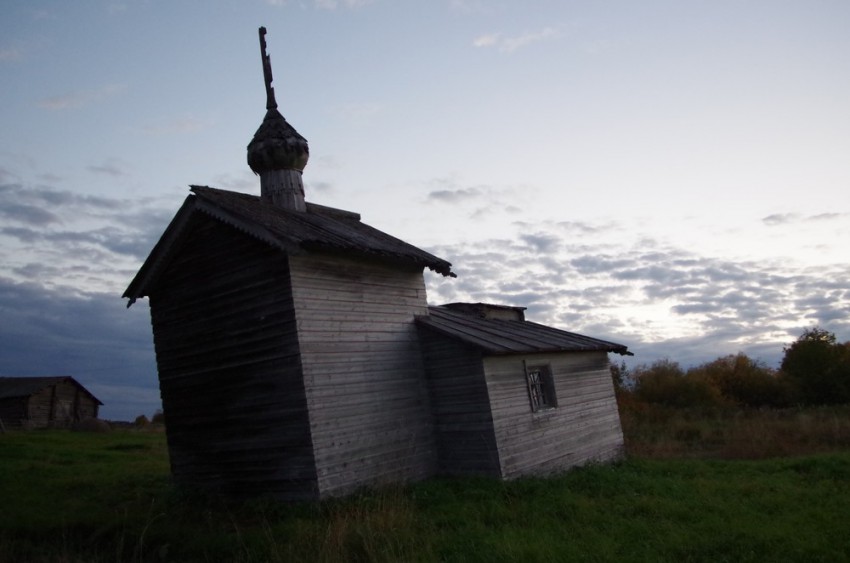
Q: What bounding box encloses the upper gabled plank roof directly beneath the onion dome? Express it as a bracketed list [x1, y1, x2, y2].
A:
[124, 186, 455, 306]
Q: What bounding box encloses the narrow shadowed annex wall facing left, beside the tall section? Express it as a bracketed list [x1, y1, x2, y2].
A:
[419, 328, 501, 476]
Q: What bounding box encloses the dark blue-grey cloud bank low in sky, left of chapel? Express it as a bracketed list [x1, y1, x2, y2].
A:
[0, 277, 161, 420]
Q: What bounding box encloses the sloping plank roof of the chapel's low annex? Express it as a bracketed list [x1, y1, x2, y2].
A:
[416, 307, 632, 356]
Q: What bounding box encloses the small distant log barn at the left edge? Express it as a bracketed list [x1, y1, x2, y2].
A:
[0, 376, 103, 428]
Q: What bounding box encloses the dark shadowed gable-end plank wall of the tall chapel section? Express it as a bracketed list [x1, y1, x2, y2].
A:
[150, 218, 318, 499]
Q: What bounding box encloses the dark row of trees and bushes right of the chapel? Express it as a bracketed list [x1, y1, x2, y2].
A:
[611, 327, 850, 408]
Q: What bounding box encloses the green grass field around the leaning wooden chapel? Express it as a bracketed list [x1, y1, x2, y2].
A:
[0, 409, 850, 563]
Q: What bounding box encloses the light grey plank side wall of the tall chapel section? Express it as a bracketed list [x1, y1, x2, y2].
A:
[290, 255, 435, 496]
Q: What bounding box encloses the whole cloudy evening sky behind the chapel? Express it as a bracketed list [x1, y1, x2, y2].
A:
[0, 0, 850, 419]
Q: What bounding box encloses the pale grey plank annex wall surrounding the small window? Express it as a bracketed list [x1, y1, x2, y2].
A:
[484, 352, 623, 478]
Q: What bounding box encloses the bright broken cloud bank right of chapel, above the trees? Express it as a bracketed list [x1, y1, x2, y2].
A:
[428, 222, 850, 365]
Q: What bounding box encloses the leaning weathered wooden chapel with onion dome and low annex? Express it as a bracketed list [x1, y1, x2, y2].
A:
[124, 28, 627, 499]
